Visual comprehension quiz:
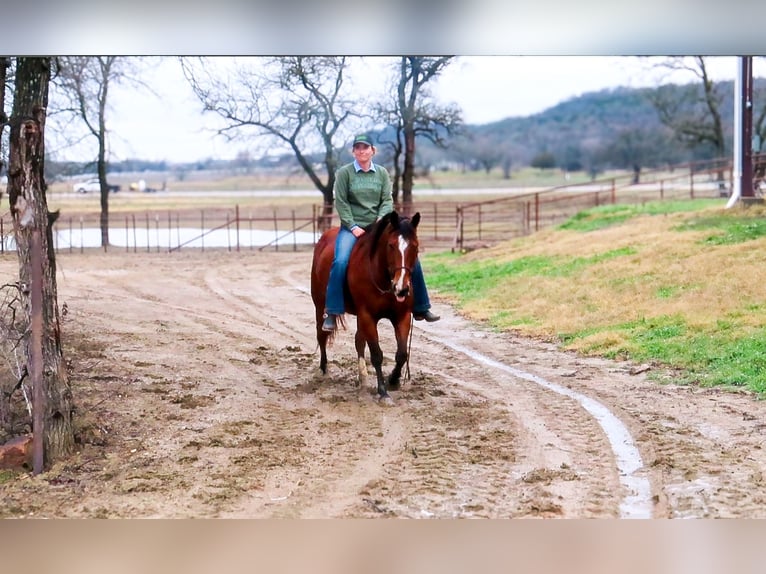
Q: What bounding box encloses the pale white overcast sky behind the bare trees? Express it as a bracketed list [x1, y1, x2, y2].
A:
[68, 56, 763, 162]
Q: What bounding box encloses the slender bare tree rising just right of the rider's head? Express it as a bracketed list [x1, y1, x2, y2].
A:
[394, 56, 462, 213]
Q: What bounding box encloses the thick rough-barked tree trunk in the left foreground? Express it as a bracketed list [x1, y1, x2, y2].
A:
[8, 58, 74, 463]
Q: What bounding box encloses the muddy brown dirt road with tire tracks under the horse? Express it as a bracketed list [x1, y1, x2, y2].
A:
[0, 251, 766, 518]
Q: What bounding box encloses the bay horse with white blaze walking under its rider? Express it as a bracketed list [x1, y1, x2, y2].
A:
[311, 211, 420, 400]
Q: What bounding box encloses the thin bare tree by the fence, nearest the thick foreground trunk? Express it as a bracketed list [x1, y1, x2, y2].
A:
[54, 56, 139, 249]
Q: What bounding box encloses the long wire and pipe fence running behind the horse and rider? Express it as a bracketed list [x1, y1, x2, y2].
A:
[0, 156, 756, 253]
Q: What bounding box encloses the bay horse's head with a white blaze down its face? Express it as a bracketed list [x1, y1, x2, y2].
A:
[376, 211, 420, 303]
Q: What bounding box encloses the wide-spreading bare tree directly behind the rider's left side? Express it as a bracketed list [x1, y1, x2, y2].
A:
[181, 56, 360, 227]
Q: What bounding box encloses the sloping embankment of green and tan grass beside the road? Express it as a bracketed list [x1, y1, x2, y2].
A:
[424, 200, 766, 395]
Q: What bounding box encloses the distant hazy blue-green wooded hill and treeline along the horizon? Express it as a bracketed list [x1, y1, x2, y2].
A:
[46, 78, 766, 180]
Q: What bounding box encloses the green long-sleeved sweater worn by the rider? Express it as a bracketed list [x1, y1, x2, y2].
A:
[334, 162, 394, 229]
